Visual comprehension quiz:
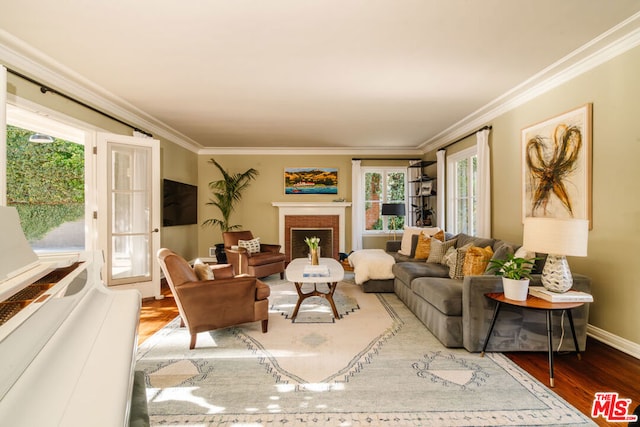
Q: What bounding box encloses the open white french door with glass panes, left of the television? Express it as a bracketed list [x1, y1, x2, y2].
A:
[97, 133, 160, 298]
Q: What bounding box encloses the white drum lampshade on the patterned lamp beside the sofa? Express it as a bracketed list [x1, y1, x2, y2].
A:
[522, 217, 589, 256]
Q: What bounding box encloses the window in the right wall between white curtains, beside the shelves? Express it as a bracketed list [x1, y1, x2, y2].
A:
[447, 147, 478, 236]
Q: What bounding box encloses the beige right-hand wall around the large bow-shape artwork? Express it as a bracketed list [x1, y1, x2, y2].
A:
[430, 43, 640, 345]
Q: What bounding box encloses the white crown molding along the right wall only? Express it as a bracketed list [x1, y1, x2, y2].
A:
[418, 13, 640, 153]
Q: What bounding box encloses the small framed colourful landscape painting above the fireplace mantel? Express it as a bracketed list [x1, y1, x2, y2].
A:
[284, 167, 338, 194]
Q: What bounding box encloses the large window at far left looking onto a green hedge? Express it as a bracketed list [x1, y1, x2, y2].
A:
[3, 105, 87, 253]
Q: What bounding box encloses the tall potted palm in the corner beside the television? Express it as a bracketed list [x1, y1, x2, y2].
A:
[202, 159, 259, 263]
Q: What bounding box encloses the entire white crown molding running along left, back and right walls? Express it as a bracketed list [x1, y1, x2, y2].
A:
[0, 13, 640, 156]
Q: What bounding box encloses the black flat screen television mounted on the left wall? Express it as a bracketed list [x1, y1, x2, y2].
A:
[162, 179, 198, 227]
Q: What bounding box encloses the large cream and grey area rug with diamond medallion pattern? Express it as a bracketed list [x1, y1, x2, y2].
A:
[136, 279, 594, 426]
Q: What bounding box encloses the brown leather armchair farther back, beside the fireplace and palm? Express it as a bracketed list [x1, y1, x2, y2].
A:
[222, 231, 285, 279]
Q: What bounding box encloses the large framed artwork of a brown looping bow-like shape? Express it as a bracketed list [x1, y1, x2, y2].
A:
[522, 104, 592, 227]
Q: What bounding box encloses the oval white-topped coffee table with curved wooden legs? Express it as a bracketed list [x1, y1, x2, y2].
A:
[285, 258, 344, 320]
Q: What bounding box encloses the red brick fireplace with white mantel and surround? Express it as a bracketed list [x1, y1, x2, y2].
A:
[272, 202, 351, 261]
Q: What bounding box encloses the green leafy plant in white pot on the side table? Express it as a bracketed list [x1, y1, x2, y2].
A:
[489, 254, 535, 301]
